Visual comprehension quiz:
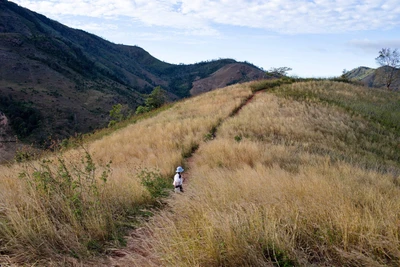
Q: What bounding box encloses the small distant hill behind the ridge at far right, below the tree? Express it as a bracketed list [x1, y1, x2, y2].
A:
[344, 67, 400, 90]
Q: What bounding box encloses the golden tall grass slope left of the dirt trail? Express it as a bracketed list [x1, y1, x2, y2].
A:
[0, 85, 251, 265]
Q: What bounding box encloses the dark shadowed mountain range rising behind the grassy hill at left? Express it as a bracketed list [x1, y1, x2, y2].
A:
[0, 0, 265, 147]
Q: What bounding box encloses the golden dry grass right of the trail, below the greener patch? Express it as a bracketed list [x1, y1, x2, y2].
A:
[142, 82, 400, 266]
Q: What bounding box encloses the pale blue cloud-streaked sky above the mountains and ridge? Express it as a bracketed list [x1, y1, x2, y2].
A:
[13, 0, 400, 77]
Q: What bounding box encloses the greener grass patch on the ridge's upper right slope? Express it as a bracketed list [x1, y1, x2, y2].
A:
[274, 82, 400, 172]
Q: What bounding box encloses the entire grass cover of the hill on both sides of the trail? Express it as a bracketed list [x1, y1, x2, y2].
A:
[0, 81, 400, 266]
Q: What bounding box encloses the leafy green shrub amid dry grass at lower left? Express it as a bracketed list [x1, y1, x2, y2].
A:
[7, 151, 118, 257]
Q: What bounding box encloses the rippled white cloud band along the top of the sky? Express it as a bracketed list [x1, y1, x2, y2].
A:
[16, 0, 400, 35]
